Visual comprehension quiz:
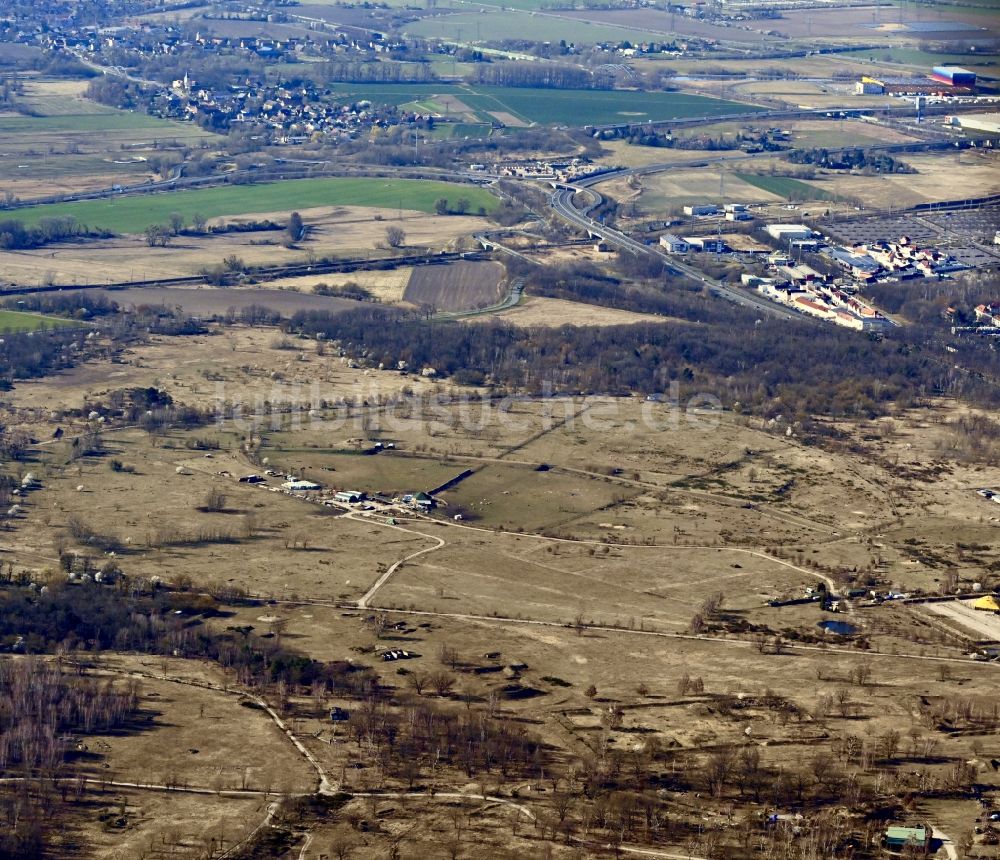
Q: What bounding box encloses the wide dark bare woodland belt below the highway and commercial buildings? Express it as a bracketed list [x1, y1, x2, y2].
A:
[288, 308, 998, 417]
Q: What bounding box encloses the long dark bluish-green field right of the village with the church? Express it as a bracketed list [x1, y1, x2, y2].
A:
[328, 84, 757, 125]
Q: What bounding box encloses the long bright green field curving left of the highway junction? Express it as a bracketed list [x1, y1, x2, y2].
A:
[3, 178, 497, 233]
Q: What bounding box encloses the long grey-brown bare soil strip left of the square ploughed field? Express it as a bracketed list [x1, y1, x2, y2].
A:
[59, 287, 361, 317]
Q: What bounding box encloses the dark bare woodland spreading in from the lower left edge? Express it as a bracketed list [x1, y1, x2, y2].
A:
[0, 576, 381, 860]
